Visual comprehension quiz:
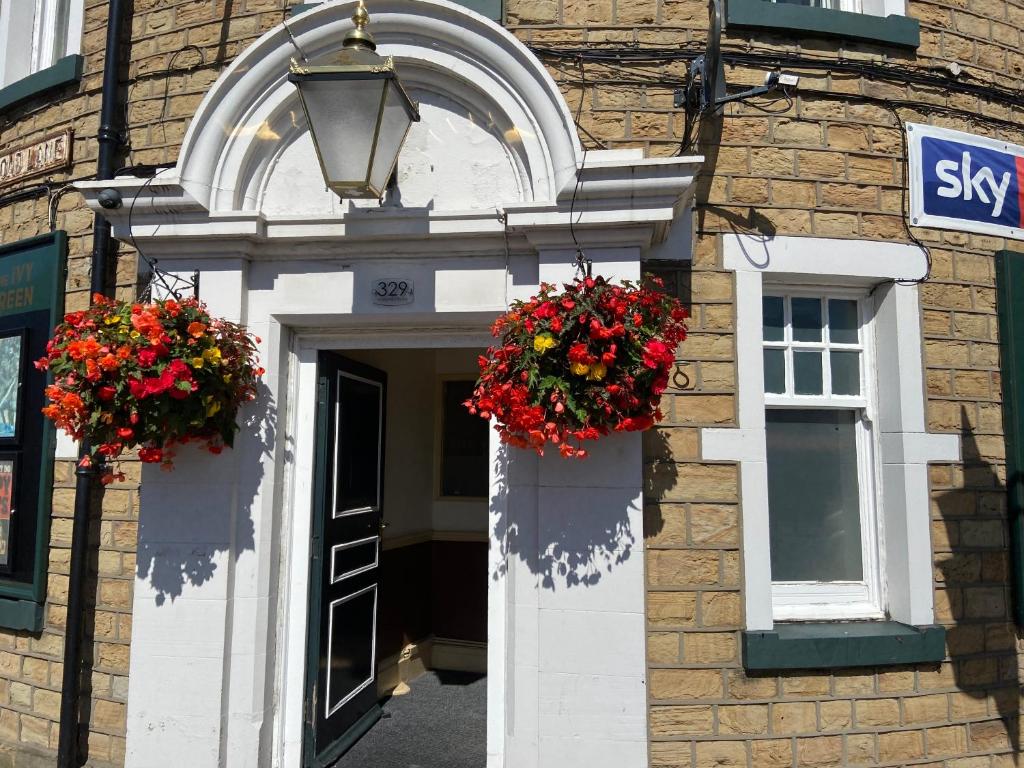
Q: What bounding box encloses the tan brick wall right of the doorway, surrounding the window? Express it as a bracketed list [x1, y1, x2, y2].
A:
[507, 0, 1024, 768]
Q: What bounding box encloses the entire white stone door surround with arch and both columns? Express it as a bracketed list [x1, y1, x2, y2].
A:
[80, 0, 700, 768]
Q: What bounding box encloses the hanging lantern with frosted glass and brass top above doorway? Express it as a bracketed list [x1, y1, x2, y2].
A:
[288, 0, 420, 198]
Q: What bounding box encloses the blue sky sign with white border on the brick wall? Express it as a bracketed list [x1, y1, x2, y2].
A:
[906, 123, 1024, 240]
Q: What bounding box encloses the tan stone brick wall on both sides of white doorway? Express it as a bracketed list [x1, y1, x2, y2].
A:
[0, 0, 1024, 768]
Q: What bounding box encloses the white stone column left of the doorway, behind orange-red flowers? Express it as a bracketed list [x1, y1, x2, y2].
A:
[126, 259, 284, 768]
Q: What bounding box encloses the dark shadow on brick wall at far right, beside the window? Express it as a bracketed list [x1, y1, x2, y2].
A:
[933, 407, 1021, 765]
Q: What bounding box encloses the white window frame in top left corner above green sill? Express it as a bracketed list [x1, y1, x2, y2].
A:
[0, 0, 85, 88]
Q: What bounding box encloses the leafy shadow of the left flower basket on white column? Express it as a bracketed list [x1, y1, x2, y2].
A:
[135, 385, 282, 605]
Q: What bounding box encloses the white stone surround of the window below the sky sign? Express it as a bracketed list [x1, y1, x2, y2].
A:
[700, 234, 959, 631]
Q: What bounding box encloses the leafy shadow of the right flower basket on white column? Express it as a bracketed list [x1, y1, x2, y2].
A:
[490, 436, 642, 592]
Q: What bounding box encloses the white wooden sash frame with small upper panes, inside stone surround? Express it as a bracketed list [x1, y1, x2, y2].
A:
[762, 283, 885, 621]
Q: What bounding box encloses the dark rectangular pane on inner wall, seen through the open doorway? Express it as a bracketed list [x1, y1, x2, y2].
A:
[441, 381, 489, 497]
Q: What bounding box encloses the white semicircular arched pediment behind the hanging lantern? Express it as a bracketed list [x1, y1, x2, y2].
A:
[172, 0, 581, 218]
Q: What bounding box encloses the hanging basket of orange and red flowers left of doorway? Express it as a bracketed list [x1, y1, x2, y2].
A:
[36, 295, 264, 482]
